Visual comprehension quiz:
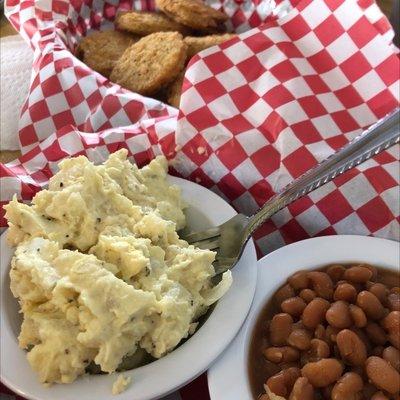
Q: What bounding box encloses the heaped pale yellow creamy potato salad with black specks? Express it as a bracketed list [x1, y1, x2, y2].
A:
[6, 150, 232, 383]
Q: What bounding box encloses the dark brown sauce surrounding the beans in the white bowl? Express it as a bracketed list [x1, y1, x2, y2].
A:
[248, 264, 400, 399]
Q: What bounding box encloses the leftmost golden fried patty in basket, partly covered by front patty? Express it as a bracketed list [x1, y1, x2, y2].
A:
[77, 31, 137, 78]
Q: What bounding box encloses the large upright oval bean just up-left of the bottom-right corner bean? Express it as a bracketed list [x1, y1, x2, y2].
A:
[336, 329, 367, 366]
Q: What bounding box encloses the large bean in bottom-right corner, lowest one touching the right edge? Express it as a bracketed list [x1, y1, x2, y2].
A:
[365, 356, 400, 394]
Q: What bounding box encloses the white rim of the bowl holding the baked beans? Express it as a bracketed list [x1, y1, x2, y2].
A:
[208, 235, 400, 400]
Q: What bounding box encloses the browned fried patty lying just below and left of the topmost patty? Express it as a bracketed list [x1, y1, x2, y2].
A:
[115, 11, 189, 36]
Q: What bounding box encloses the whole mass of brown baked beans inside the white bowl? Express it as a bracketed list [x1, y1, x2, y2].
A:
[251, 264, 400, 400]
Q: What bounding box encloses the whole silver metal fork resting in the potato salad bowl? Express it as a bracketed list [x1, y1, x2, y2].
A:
[183, 108, 400, 274]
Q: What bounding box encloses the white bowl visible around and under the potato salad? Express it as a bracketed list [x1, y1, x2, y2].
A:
[0, 177, 257, 400]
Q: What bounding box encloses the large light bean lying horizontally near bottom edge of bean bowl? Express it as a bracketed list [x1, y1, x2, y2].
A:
[301, 358, 343, 387]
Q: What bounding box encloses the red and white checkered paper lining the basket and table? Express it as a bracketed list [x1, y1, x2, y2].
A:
[0, 0, 400, 400]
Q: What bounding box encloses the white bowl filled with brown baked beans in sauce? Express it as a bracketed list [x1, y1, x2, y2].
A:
[209, 236, 400, 400]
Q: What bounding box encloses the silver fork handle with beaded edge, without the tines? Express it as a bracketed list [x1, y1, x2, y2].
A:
[246, 108, 400, 236]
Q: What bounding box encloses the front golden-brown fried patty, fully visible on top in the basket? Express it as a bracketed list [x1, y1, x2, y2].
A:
[110, 32, 187, 95]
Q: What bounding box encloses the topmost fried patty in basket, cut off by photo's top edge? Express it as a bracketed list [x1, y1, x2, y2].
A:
[156, 0, 228, 32]
